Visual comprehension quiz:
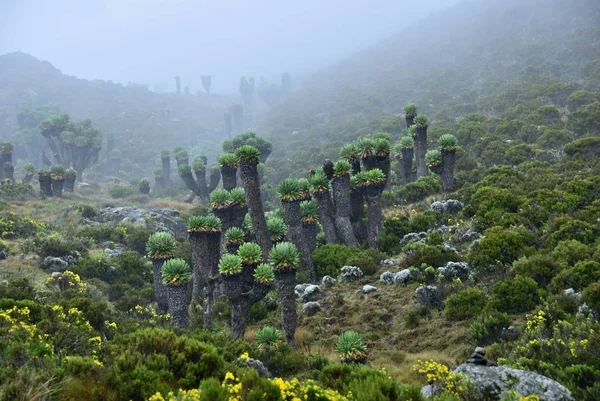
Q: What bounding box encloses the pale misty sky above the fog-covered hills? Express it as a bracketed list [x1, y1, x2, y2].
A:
[0, 0, 458, 92]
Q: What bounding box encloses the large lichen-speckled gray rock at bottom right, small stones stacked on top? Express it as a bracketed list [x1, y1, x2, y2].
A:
[455, 363, 574, 401]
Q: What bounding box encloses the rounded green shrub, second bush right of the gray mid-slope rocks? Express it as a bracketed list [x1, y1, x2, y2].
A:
[490, 276, 539, 313]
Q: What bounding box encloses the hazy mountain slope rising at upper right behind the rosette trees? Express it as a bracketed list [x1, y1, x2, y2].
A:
[265, 0, 600, 182]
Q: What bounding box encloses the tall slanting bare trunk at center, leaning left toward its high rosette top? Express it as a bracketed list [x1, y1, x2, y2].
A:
[240, 164, 271, 260]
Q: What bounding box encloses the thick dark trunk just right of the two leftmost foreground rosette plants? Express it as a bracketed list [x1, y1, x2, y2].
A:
[189, 231, 221, 329]
